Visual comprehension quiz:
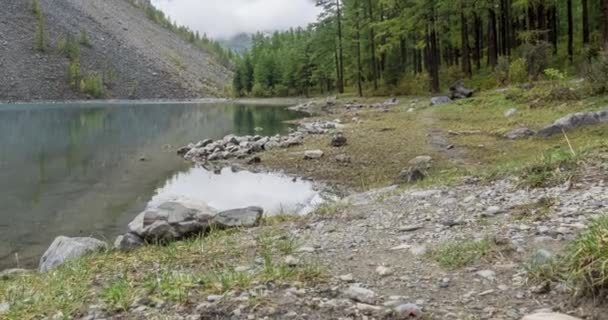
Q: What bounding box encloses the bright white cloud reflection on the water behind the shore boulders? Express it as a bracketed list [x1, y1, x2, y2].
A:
[149, 167, 322, 214]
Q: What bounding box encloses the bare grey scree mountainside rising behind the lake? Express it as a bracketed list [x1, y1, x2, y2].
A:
[0, 0, 232, 101]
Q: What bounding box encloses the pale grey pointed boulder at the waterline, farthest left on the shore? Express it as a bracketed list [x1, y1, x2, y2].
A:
[38, 236, 108, 272]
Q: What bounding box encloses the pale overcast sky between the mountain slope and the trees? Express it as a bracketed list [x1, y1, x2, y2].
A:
[152, 0, 319, 38]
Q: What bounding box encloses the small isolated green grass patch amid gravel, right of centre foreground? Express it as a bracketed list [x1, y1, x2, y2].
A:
[427, 239, 497, 269]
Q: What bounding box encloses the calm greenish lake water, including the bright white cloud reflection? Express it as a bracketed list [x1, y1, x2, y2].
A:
[0, 102, 317, 270]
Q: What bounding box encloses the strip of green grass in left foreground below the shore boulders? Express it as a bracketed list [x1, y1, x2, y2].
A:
[0, 225, 325, 319]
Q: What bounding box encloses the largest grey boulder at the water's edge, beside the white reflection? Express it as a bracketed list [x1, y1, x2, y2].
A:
[123, 199, 216, 242]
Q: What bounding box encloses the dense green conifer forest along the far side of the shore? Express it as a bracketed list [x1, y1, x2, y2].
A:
[233, 0, 608, 96]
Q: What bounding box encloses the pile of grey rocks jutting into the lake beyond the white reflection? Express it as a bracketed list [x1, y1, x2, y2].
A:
[177, 121, 341, 164]
